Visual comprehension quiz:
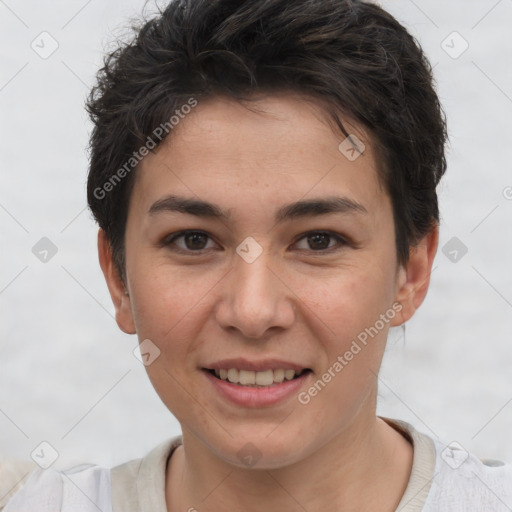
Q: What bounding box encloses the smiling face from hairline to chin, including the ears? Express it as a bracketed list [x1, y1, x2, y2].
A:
[100, 95, 436, 468]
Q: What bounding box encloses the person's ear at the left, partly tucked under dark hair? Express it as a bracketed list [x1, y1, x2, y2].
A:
[98, 229, 137, 334]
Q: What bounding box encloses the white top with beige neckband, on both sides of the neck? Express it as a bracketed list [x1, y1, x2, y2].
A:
[0, 418, 512, 512]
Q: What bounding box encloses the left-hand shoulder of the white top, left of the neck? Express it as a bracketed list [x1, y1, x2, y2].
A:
[0, 436, 182, 512]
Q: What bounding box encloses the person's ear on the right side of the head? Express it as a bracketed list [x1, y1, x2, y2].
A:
[391, 225, 439, 327]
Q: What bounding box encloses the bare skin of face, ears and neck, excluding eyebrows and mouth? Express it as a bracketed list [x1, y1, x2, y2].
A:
[99, 94, 438, 512]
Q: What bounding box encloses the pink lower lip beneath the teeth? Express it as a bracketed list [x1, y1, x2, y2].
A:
[203, 370, 311, 408]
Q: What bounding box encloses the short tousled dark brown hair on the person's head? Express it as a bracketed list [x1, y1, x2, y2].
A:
[87, 0, 447, 276]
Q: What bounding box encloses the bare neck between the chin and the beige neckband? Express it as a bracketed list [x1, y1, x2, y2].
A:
[166, 413, 413, 512]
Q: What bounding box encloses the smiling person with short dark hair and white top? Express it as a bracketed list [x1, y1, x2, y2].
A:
[4, 0, 512, 512]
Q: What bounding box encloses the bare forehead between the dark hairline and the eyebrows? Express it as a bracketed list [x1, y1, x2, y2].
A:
[131, 95, 387, 221]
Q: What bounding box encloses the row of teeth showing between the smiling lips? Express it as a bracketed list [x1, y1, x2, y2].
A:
[203, 368, 311, 388]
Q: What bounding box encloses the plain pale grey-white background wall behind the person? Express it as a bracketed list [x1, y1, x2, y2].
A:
[0, 0, 512, 466]
